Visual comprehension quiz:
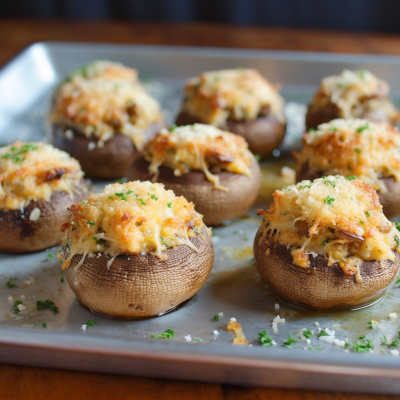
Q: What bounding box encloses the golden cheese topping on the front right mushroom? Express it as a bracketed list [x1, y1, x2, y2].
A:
[261, 176, 400, 281]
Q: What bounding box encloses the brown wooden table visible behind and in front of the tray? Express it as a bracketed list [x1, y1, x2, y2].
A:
[0, 20, 400, 400]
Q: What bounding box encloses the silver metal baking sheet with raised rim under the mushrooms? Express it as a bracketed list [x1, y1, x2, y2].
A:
[0, 42, 400, 393]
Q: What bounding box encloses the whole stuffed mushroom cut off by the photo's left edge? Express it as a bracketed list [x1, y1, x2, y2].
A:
[0, 141, 87, 253]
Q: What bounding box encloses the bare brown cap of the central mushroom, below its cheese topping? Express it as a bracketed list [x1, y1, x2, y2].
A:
[127, 153, 261, 226]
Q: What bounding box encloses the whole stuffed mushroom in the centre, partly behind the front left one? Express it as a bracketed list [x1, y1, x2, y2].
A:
[128, 124, 261, 226]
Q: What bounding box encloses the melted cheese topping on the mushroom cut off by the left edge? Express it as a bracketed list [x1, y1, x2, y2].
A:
[0, 142, 83, 210]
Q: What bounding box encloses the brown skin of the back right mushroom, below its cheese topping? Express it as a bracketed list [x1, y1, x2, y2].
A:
[306, 102, 397, 130]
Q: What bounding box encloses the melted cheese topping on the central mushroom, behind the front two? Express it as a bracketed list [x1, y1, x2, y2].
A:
[144, 124, 255, 191]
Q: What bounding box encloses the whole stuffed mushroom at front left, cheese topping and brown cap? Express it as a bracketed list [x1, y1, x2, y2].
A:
[59, 181, 214, 318]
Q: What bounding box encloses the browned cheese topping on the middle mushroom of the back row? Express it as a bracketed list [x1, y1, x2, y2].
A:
[182, 68, 284, 126]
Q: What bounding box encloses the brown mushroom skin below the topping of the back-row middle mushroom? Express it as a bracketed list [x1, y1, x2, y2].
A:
[175, 110, 286, 159]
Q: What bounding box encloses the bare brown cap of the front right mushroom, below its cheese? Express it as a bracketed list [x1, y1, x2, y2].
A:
[254, 227, 400, 310]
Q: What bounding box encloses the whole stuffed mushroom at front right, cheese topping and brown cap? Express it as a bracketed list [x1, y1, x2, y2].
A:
[254, 176, 400, 310]
